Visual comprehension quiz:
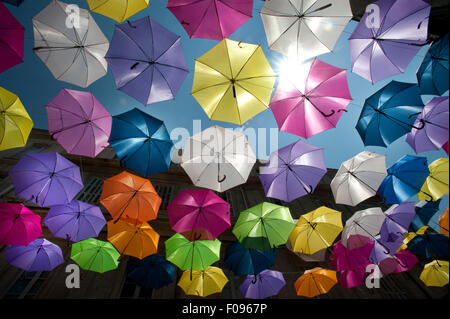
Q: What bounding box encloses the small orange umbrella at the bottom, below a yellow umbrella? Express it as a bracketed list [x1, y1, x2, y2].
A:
[294, 267, 337, 298]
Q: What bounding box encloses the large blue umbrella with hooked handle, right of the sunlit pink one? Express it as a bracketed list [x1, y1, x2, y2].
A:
[356, 81, 424, 147]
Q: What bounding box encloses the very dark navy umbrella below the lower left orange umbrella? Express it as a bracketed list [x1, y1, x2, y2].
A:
[127, 255, 177, 289]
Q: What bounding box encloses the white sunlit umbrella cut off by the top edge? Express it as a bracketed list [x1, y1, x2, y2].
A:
[260, 0, 353, 60]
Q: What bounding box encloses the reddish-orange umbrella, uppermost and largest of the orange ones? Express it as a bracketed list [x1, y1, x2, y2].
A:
[100, 172, 161, 222]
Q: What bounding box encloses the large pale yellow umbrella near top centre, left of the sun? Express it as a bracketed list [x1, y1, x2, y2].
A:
[191, 39, 277, 125]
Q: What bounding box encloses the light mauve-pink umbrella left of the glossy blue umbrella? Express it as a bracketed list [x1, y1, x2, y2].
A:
[46, 89, 111, 157]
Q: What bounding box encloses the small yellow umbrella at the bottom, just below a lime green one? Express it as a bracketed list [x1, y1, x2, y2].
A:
[178, 267, 228, 297]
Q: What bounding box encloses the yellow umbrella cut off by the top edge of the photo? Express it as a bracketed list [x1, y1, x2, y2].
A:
[87, 0, 149, 23]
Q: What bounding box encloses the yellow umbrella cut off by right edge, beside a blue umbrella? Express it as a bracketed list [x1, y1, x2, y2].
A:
[417, 158, 448, 202]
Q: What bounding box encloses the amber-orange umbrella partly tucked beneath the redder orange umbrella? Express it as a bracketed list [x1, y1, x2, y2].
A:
[107, 220, 159, 259]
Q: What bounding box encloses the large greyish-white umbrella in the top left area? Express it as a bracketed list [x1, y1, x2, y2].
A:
[33, 1, 109, 88]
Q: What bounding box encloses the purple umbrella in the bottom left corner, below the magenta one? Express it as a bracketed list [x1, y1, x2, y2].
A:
[5, 238, 64, 272]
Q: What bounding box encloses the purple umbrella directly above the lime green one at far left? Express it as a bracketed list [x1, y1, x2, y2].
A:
[44, 200, 106, 242]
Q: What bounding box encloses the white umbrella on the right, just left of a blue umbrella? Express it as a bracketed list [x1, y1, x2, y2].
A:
[330, 151, 387, 206]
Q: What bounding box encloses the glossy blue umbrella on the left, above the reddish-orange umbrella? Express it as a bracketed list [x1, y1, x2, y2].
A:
[109, 109, 174, 176]
